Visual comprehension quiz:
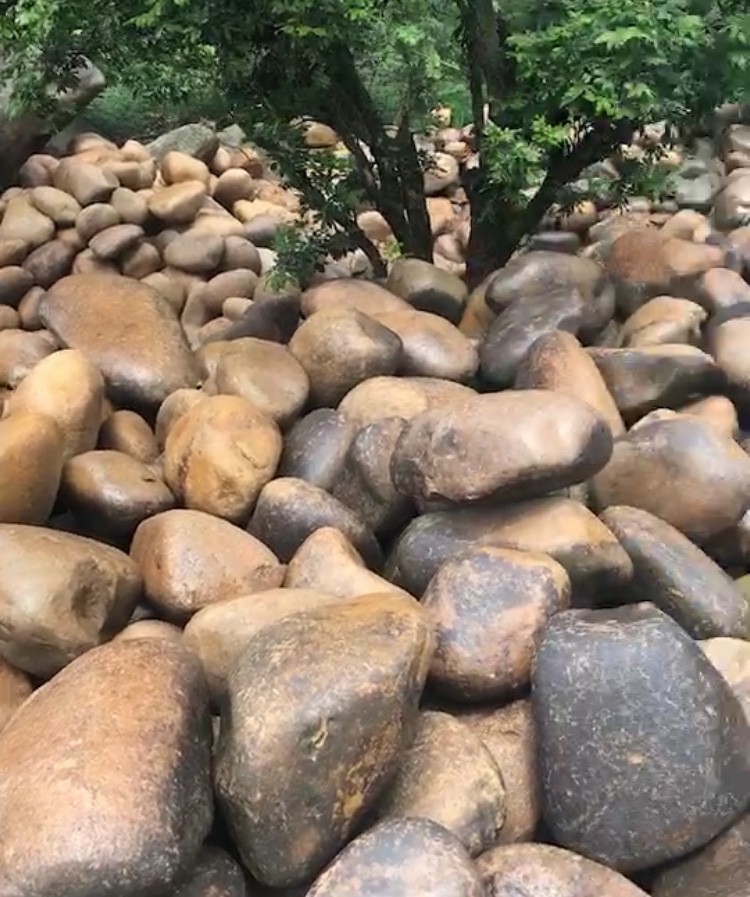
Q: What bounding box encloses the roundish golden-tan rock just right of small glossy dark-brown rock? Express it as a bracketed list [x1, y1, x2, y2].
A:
[164, 396, 282, 523]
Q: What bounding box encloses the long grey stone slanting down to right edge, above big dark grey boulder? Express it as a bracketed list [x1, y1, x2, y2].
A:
[601, 506, 750, 639]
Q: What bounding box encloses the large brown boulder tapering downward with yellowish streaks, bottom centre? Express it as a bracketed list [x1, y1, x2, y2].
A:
[215, 595, 432, 887]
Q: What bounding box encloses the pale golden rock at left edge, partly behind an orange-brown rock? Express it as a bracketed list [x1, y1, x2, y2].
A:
[5, 349, 104, 461]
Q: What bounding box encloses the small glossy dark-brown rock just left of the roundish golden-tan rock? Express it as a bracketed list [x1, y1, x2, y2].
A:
[60, 449, 175, 541]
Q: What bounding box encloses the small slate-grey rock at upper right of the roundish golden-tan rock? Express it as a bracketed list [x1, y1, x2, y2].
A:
[278, 408, 356, 491]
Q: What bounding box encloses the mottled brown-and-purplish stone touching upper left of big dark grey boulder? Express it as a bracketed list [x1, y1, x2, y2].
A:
[422, 546, 570, 704]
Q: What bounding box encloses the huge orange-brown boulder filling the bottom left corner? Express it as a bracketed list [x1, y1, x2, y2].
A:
[0, 639, 213, 897]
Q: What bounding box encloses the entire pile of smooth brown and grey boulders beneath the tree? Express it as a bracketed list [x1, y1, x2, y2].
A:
[0, 121, 750, 897]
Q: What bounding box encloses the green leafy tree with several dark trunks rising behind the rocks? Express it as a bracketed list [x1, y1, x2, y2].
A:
[0, 0, 750, 284]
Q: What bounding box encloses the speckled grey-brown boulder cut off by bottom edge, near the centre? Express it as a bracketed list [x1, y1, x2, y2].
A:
[307, 819, 485, 897]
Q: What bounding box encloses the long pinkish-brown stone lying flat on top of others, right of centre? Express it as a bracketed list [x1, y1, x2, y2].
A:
[390, 390, 612, 502]
